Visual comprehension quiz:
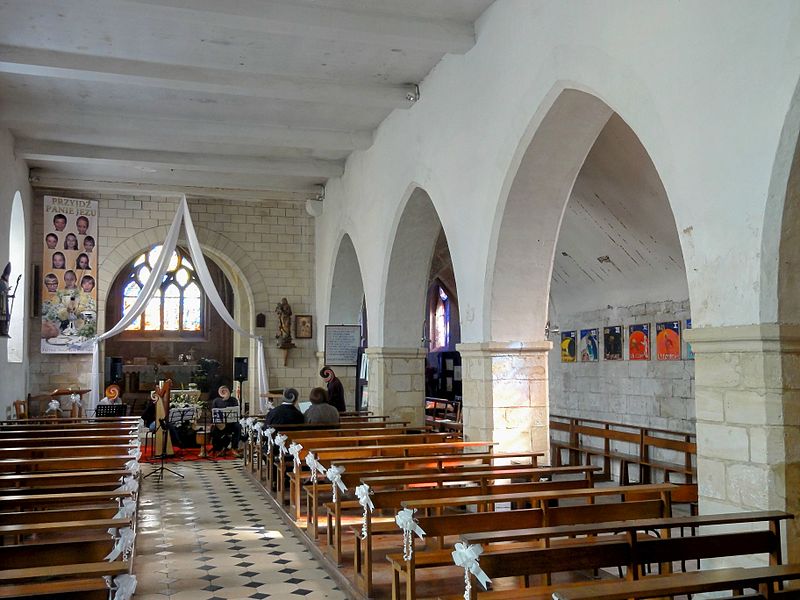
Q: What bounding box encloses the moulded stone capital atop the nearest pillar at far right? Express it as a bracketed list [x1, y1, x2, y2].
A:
[684, 323, 800, 354]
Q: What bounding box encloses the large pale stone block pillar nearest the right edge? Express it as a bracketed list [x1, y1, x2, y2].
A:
[686, 324, 800, 562]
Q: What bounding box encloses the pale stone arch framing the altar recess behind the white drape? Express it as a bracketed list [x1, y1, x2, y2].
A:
[98, 219, 269, 398]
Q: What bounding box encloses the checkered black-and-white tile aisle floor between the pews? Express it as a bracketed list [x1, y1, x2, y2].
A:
[134, 460, 346, 600]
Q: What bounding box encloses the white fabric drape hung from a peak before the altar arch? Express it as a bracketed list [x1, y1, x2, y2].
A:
[90, 196, 269, 411]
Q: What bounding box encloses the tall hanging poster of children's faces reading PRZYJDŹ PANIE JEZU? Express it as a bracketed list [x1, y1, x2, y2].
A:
[41, 196, 98, 354]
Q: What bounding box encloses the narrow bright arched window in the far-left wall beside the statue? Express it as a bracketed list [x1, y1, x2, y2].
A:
[7, 192, 27, 363]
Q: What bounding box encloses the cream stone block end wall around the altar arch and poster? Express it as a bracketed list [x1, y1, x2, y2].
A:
[29, 190, 321, 399]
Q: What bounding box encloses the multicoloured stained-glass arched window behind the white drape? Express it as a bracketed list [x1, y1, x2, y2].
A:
[121, 245, 205, 337]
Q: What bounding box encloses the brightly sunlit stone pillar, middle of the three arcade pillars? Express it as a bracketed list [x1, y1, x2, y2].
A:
[456, 341, 553, 454]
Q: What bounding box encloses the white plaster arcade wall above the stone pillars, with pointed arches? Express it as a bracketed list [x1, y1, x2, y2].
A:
[316, 0, 800, 346]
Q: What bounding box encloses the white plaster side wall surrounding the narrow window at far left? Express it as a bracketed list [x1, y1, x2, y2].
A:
[0, 129, 31, 419]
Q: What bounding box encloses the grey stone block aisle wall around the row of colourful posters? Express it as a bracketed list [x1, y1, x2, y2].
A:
[549, 300, 695, 431]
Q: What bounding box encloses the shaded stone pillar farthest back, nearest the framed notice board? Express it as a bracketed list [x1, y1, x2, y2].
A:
[366, 347, 427, 426]
